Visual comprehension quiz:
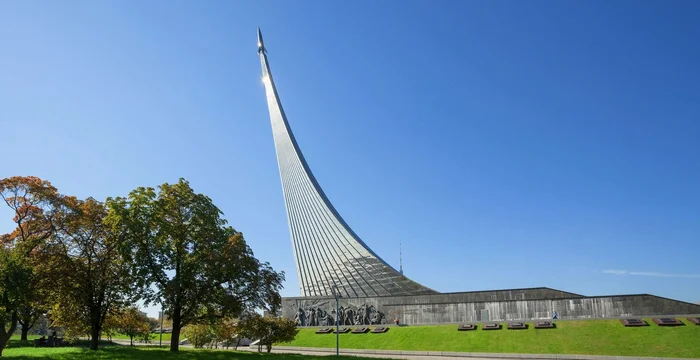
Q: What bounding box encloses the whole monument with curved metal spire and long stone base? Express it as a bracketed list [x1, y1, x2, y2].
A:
[258, 29, 700, 326]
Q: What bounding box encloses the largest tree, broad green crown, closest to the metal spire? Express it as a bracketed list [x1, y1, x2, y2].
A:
[107, 179, 284, 351]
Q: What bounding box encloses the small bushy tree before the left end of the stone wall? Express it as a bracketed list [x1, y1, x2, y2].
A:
[239, 313, 299, 352]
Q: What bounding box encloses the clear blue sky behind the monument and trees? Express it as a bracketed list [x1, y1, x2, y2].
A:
[0, 1, 700, 316]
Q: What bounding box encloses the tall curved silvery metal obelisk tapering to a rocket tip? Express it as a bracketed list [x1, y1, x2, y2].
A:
[258, 28, 437, 297]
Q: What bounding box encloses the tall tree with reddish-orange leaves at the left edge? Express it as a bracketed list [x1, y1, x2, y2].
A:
[0, 176, 62, 341]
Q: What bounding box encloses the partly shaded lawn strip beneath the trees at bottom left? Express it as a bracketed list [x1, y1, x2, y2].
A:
[2, 346, 374, 360]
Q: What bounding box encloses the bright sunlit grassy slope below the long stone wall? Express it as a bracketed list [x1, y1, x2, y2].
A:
[281, 319, 700, 358]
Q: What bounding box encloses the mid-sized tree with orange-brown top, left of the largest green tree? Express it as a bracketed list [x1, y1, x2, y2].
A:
[39, 197, 131, 350]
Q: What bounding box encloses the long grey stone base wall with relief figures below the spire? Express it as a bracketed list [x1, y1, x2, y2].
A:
[283, 288, 700, 326]
